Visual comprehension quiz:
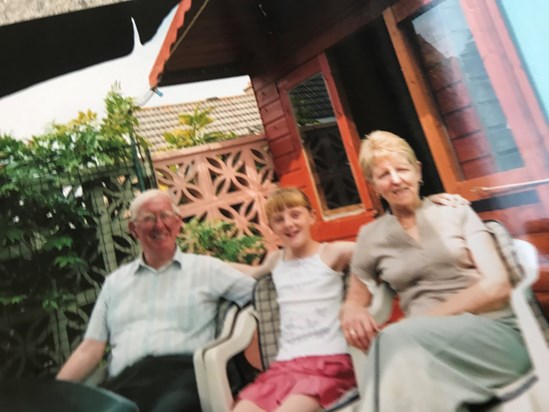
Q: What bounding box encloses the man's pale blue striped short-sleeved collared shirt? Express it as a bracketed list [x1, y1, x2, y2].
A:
[85, 249, 255, 376]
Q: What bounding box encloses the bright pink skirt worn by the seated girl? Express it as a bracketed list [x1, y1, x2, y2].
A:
[238, 354, 356, 411]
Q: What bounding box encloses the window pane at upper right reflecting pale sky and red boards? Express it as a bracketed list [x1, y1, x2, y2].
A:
[411, 0, 524, 179]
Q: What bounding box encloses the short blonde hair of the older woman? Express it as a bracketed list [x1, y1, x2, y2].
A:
[358, 130, 418, 181]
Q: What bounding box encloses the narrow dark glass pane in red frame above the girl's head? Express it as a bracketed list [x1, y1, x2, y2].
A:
[290, 73, 360, 210]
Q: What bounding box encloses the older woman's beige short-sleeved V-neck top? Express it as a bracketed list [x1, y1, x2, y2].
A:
[351, 199, 487, 316]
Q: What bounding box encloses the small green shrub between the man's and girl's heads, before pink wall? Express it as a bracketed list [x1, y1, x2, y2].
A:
[179, 218, 265, 264]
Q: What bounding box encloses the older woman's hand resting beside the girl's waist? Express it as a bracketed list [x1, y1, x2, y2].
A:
[340, 302, 379, 350]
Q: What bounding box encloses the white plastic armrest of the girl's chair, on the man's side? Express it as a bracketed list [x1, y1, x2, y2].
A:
[203, 306, 257, 412]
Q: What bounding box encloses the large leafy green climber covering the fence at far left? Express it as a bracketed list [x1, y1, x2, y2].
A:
[0, 88, 141, 310]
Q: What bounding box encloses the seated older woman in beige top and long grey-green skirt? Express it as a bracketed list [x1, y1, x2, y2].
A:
[341, 131, 530, 412]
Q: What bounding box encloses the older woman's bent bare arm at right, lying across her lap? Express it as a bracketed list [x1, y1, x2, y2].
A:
[426, 232, 512, 316]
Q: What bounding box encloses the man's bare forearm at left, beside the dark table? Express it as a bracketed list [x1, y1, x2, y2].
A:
[56, 339, 106, 382]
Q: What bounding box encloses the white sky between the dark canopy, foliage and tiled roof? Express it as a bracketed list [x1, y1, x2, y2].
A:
[0, 9, 249, 139]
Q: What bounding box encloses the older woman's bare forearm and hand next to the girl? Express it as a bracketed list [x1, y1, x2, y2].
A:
[339, 273, 379, 350]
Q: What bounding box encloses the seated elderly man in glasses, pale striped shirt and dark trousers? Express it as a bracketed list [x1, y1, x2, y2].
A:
[57, 189, 254, 411]
